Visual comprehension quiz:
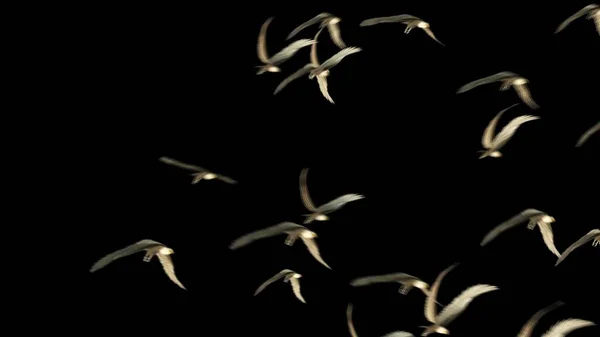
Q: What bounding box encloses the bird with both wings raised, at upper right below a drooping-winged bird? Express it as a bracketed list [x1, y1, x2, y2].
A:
[479, 104, 540, 159]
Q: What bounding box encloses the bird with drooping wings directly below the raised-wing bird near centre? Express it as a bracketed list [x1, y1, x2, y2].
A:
[229, 222, 331, 269]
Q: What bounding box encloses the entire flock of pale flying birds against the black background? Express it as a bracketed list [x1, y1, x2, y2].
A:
[90, 4, 600, 337]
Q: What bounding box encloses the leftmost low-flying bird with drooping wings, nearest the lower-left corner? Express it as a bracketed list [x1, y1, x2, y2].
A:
[90, 239, 186, 290]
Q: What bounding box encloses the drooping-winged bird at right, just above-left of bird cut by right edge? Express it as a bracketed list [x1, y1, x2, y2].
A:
[480, 208, 560, 257]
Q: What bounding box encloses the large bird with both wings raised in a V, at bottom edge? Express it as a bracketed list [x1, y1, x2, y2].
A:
[420, 263, 499, 337]
